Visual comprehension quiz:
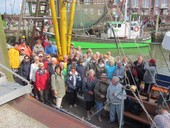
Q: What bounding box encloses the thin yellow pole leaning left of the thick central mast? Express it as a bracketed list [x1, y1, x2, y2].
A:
[50, 0, 62, 55]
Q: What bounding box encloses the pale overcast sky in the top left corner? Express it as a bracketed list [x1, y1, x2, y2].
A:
[0, 0, 22, 14]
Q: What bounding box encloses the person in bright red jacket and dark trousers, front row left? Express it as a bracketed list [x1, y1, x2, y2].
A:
[35, 63, 50, 103]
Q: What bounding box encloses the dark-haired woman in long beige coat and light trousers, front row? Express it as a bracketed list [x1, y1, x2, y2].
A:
[51, 65, 66, 108]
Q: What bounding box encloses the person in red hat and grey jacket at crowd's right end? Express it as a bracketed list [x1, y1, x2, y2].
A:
[143, 59, 156, 101]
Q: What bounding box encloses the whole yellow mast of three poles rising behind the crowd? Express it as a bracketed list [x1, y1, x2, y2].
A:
[50, 0, 76, 57]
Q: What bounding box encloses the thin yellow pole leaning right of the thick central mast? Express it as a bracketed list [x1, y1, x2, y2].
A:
[67, 0, 76, 54]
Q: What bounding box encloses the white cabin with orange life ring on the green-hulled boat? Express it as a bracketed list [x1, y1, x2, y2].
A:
[106, 21, 141, 39]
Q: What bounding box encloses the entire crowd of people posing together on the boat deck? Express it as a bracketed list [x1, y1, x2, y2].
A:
[8, 36, 166, 126]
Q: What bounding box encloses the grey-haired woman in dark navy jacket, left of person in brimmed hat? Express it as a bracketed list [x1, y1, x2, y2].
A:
[82, 69, 97, 119]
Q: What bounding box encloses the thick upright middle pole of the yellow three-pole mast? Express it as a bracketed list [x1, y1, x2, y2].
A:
[60, 0, 67, 56]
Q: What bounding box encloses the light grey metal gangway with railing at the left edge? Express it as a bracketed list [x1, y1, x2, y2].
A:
[0, 64, 32, 105]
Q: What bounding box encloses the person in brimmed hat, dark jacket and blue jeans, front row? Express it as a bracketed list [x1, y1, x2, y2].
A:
[94, 73, 109, 122]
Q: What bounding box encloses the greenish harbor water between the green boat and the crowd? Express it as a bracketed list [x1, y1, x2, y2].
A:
[89, 44, 170, 76]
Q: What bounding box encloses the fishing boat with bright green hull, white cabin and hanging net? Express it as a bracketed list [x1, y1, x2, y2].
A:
[28, 1, 151, 49]
